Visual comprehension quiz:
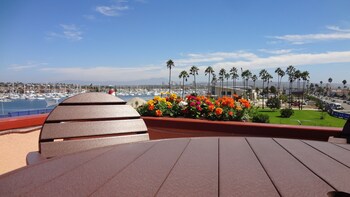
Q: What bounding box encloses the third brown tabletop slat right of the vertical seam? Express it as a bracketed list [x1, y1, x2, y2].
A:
[276, 139, 350, 192]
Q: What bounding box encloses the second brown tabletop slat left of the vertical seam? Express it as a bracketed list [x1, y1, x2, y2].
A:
[93, 139, 190, 196]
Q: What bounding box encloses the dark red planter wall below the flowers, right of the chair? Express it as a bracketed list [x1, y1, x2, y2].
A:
[142, 116, 342, 141]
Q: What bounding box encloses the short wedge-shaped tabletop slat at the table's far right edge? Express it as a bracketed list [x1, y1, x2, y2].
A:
[303, 140, 350, 168]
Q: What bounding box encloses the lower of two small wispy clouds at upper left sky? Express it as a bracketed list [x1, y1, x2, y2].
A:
[47, 24, 83, 41]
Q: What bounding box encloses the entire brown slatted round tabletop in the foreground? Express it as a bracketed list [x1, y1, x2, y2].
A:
[0, 137, 350, 196]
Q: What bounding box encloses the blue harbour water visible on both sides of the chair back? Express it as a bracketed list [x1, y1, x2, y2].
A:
[0, 95, 153, 115]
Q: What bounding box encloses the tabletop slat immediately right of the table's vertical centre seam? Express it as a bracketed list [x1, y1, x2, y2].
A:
[219, 138, 279, 197]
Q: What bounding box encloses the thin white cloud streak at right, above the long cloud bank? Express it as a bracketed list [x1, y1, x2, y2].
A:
[272, 26, 350, 44]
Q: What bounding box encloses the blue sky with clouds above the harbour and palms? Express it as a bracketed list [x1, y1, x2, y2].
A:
[0, 0, 350, 83]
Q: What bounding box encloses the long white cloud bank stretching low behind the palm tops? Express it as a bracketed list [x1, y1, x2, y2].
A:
[39, 51, 350, 81]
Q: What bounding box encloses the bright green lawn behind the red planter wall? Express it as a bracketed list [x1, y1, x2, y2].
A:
[258, 109, 346, 127]
